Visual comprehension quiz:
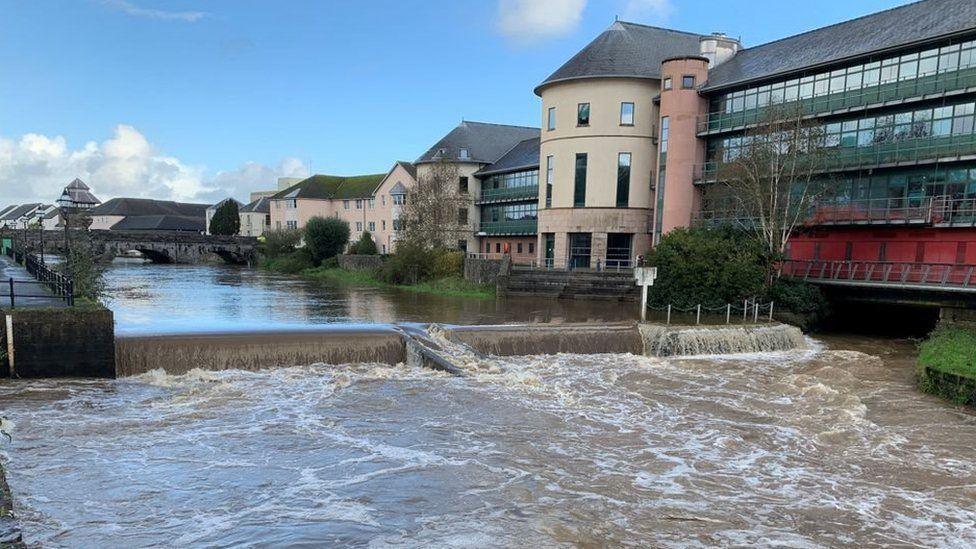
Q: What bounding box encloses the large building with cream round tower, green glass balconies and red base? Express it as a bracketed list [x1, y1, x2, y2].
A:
[535, 0, 976, 267]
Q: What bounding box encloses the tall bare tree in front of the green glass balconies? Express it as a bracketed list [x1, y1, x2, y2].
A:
[709, 106, 832, 257]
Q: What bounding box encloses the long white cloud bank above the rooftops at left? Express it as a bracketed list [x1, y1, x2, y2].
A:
[0, 125, 307, 207]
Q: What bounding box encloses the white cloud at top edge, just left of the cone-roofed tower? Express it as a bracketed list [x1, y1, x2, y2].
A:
[498, 0, 586, 44]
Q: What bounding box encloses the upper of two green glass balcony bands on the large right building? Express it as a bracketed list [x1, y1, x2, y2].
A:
[698, 68, 976, 135]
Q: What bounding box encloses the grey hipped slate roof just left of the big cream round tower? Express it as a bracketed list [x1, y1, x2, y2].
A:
[414, 121, 541, 164]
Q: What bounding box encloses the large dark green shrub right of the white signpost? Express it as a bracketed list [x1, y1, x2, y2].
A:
[648, 228, 771, 307]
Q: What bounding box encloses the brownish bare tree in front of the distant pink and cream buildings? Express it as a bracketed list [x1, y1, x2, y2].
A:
[401, 157, 473, 248]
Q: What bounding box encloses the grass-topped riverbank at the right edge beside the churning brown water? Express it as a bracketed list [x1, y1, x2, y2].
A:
[918, 324, 976, 406]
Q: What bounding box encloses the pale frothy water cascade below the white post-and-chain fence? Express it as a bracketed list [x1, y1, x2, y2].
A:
[638, 324, 807, 357]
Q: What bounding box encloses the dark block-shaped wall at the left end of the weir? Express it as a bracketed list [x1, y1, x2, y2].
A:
[0, 307, 115, 378]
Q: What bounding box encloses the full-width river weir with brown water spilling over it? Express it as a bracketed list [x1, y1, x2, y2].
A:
[115, 323, 806, 376]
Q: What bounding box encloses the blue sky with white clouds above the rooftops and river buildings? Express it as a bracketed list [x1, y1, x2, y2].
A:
[0, 0, 906, 208]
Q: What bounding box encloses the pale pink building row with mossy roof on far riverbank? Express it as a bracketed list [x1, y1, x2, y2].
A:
[268, 158, 417, 253]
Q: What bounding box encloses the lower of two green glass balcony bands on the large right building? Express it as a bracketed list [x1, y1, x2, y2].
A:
[692, 134, 976, 184]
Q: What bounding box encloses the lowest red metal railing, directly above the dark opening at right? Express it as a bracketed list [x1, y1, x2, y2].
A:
[777, 259, 976, 291]
